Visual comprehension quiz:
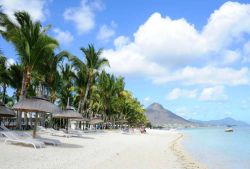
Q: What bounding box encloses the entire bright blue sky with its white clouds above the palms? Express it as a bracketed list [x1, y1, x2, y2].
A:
[0, 0, 250, 122]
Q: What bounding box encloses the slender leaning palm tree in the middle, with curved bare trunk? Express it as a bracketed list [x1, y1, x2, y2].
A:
[81, 45, 109, 111]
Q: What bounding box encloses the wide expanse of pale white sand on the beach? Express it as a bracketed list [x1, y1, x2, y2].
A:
[0, 130, 204, 169]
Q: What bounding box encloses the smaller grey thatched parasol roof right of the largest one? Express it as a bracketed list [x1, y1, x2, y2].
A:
[53, 107, 83, 119]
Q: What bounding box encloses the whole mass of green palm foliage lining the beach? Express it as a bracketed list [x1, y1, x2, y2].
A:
[0, 11, 148, 127]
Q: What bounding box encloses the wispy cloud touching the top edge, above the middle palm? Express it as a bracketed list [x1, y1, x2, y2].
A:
[63, 0, 103, 34]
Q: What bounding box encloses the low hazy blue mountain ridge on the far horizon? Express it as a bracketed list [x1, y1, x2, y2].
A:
[189, 117, 249, 126]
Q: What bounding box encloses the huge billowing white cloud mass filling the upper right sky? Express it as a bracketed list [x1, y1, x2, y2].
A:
[103, 2, 250, 85]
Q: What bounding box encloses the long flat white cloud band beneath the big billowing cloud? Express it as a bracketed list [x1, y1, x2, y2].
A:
[153, 66, 250, 86]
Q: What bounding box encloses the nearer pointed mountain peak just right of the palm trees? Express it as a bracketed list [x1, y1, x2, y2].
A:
[145, 103, 193, 127]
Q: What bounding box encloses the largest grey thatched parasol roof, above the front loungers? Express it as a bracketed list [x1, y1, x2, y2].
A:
[13, 97, 62, 113]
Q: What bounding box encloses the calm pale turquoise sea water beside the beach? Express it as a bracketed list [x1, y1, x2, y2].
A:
[182, 127, 250, 169]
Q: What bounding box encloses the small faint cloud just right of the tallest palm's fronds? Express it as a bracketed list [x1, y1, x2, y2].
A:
[53, 28, 74, 45]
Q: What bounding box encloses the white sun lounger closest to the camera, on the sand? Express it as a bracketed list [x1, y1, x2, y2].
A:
[0, 131, 45, 149]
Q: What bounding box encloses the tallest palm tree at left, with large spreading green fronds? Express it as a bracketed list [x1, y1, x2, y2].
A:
[0, 12, 58, 97]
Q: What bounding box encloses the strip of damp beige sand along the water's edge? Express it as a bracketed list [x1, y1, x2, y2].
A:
[170, 133, 208, 169]
